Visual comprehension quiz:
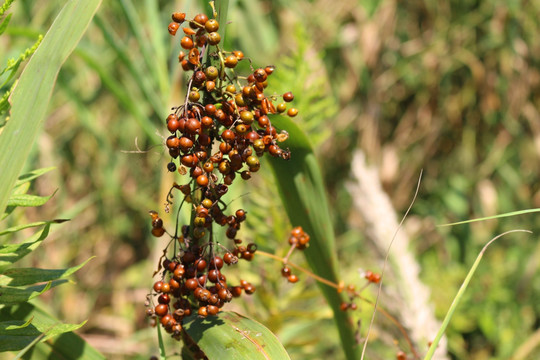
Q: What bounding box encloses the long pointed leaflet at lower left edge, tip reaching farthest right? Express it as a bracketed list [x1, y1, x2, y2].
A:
[0, 257, 94, 286]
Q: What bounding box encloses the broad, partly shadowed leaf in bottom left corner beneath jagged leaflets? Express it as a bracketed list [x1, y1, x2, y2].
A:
[0, 303, 105, 360]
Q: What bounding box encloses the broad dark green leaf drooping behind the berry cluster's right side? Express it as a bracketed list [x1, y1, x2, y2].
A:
[269, 116, 359, 359]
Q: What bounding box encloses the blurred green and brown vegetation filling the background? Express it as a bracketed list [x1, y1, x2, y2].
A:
[0, 0, 540, 359]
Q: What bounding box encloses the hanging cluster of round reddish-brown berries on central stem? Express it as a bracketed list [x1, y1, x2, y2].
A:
[147, 7, 300, 338]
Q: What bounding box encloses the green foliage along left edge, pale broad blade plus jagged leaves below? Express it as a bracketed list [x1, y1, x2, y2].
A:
[0, 1, 104, 359]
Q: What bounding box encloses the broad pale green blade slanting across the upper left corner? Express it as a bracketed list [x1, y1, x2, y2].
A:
[0, 0, 101, 217]
